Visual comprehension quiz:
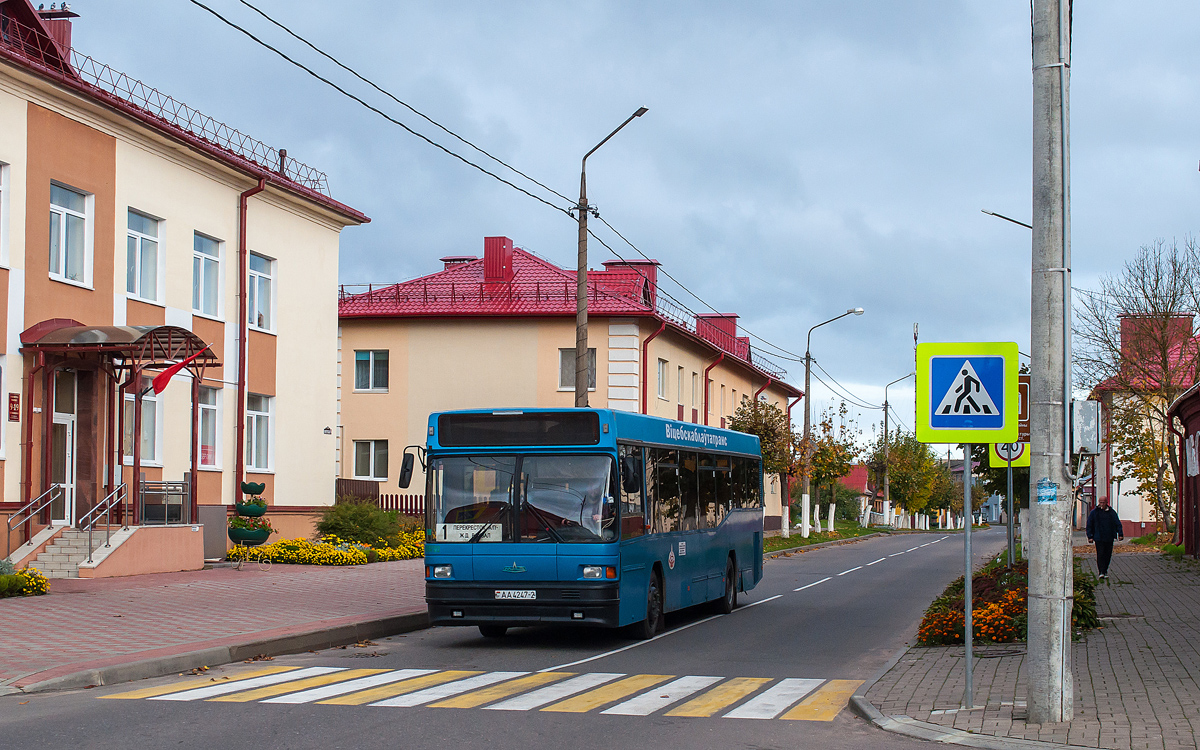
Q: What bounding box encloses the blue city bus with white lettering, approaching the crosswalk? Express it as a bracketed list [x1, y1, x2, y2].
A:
[401, 409, 763, 638]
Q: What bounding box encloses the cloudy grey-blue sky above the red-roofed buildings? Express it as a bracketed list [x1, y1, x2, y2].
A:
[72, 0, 1200, 439]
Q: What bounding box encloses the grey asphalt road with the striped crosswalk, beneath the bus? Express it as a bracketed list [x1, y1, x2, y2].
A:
[0, 528, 1004, 750]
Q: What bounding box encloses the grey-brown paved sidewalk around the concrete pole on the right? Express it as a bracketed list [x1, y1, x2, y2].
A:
[865, 554, 1200, 750]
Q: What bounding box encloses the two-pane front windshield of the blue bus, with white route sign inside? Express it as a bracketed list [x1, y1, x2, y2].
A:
[426, 455, 618, 542]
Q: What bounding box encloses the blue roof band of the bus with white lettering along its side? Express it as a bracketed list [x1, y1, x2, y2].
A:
[428, 408, 761, 456]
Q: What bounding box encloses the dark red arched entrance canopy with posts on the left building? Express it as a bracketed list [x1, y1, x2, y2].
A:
[20, 318, 221, 535]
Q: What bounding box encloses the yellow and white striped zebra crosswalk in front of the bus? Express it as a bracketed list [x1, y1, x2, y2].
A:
[97, 666, 863, 721]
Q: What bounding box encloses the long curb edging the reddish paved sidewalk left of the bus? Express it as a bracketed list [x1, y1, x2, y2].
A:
[11, 612, 430, 696]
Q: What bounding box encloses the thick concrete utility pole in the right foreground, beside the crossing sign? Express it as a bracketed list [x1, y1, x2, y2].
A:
[1025, 0, 1075, 724]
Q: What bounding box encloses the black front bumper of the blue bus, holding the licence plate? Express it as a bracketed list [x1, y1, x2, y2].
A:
[425, 581, 620, 628]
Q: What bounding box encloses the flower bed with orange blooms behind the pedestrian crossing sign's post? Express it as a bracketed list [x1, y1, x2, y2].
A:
[917, 557, 1099, 646]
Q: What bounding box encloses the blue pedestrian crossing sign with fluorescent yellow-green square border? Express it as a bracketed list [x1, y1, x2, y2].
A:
[917, 342, 1020, 443]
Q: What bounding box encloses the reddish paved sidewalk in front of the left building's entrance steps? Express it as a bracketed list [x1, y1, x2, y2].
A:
[0, 559, 425, 694]
